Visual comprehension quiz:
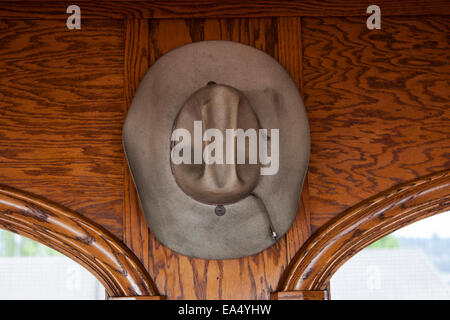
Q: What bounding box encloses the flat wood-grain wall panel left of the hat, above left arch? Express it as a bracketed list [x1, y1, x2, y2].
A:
[0, 20, 124, 237]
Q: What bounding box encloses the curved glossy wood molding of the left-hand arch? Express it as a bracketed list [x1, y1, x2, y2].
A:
[0, 185, 158, 297]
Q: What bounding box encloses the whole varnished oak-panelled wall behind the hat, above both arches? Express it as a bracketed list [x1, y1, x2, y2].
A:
[0, 6, 450, 299]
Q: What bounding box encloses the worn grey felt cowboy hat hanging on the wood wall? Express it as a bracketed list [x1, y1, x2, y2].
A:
[123, 41, 310, 259]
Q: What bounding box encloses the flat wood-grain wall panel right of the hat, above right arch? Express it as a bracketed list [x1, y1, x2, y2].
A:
[302, 17, 450, 228]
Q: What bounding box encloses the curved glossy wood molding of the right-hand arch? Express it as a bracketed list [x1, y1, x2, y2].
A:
[278, 170, 450, 291]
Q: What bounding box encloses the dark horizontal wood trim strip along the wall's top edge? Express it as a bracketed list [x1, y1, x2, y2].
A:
[0, 0, 450, 19]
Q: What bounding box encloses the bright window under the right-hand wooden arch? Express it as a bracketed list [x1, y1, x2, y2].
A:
[331, 212, 450, 300]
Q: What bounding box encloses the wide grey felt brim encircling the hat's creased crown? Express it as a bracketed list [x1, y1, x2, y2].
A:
[123, 41, 310, 259]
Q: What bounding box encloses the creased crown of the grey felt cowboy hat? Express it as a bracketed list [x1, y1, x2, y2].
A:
[172, 82, 259, 204]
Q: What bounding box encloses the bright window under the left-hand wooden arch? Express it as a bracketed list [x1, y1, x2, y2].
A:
[0, 229, 105, 300]
